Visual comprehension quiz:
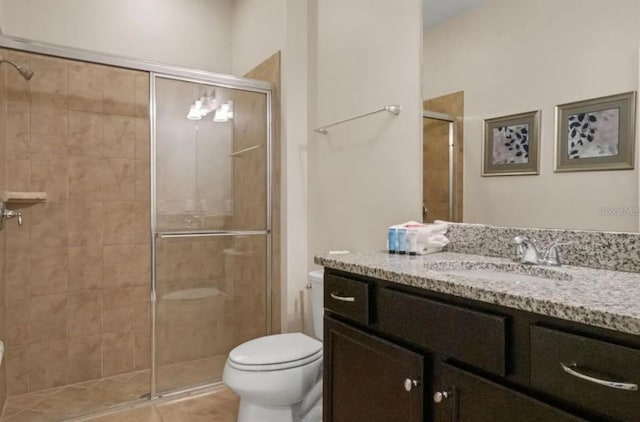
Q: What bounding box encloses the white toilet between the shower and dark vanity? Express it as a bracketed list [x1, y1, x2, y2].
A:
[222, 270, 323, 422]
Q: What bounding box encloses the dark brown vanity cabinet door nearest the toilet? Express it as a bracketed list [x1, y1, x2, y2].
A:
[324, 317, 424, 422]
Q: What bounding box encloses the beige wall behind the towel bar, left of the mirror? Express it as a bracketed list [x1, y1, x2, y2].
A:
[309, 0, 422, 256]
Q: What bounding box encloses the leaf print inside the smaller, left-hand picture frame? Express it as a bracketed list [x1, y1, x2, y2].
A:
[492, 124, 529, 164]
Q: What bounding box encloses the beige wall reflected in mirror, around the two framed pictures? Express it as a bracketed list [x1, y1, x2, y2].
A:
[423, 0, 640, 231]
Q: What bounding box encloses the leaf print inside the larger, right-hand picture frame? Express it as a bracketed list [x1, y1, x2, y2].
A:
[567, 108, 620, 160]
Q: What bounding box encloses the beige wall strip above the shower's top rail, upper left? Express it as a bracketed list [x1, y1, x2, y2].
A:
[0, 0, 235, 73]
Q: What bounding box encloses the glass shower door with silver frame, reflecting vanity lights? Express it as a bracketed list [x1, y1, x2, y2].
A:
[152, 76, 270, 395]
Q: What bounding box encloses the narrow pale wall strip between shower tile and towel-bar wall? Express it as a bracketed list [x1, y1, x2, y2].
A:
[282, 0, 316, 334]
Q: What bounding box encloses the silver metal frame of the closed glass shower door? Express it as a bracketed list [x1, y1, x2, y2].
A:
[149, 72, 273, 400]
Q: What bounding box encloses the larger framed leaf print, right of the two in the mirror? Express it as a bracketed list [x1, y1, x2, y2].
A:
[555, 92, 636, 172]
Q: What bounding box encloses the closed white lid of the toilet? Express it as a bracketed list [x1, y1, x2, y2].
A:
[229, 333, 322, 367]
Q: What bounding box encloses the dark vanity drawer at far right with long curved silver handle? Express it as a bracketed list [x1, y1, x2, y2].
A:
[530, 326, 640, 421]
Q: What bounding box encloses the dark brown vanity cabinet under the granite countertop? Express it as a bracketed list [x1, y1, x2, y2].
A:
[324, 269, 640, 422]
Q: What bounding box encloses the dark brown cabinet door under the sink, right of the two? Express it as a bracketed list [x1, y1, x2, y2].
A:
[433, 364, 585, 422]
